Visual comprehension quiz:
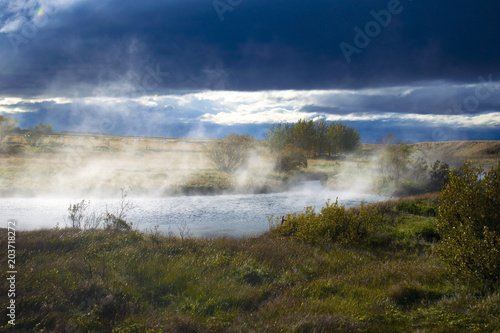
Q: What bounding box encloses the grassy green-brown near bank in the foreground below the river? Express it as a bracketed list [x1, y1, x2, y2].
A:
[0, 195, 500, 332]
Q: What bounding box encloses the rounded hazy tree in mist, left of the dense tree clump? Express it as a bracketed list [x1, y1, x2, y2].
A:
[205, 133, 255, 173]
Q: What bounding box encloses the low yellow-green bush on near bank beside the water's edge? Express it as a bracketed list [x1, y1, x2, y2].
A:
[271, 201, 382, 245]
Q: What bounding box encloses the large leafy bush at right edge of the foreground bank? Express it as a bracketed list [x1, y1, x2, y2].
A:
[437, 162, 500, 283]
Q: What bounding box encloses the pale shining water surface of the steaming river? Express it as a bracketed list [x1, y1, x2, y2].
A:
[0, 181, 386, 237]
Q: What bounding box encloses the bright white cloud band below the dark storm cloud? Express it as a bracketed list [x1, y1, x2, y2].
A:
[0, 85, 500, 128]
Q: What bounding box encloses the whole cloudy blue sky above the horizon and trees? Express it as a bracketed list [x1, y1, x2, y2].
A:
[0, 0, 500, 143]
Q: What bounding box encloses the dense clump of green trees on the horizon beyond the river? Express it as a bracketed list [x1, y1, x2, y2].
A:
[266, 119, 361, 157]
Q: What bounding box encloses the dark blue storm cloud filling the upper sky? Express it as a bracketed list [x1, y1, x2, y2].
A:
[0, 0, 500, 96]
